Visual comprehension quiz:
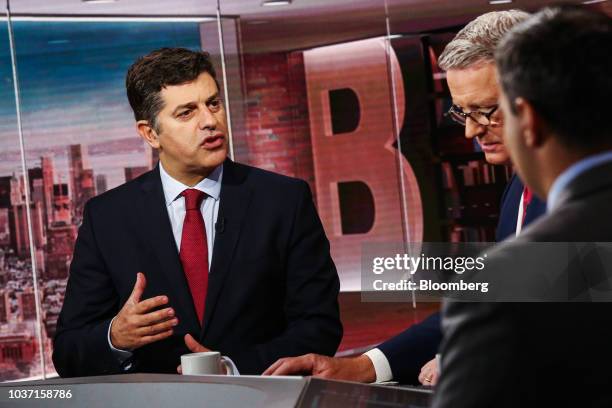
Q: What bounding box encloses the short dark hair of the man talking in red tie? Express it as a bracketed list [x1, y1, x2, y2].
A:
[125, 48, 219, 131]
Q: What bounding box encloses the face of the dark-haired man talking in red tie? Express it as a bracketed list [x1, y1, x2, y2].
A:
[157, 73, 227, 174]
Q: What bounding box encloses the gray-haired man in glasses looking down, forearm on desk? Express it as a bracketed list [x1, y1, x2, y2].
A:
[264, 10, 545, 386]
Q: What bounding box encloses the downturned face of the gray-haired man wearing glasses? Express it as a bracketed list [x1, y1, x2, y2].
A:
[446, 63, 509, 164]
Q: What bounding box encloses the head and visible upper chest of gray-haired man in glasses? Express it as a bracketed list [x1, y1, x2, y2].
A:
[438, 10, 546, 245]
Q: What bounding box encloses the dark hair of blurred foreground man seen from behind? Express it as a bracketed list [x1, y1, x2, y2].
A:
[495, 6, 612, 150]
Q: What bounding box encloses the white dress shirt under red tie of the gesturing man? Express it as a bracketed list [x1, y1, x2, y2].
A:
[108, 161, 233, 373]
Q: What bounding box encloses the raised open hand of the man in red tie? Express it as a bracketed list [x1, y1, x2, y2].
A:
[111, 272, 178, 350]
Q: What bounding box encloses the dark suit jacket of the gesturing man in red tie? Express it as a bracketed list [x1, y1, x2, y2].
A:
[53, 160, 342, 377]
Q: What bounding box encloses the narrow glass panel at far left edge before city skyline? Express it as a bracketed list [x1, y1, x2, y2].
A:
[0, 1, 46, 381]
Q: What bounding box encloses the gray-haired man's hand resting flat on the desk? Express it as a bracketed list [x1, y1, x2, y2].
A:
[263, 354, 376, 383]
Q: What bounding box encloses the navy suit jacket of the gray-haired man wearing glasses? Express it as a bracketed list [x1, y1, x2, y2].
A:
[378, 175, 546, 384]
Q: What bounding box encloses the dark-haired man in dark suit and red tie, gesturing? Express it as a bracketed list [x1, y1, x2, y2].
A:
[53, 48, 342, 377]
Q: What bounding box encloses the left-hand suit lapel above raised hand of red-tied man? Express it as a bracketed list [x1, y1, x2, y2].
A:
[139, 166, 200, 333]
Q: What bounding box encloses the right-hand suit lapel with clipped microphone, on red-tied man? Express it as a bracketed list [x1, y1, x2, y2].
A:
[200, 159, 251, 339]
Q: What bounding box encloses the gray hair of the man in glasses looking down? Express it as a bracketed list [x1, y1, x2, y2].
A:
[438, 10, 529, 71]
